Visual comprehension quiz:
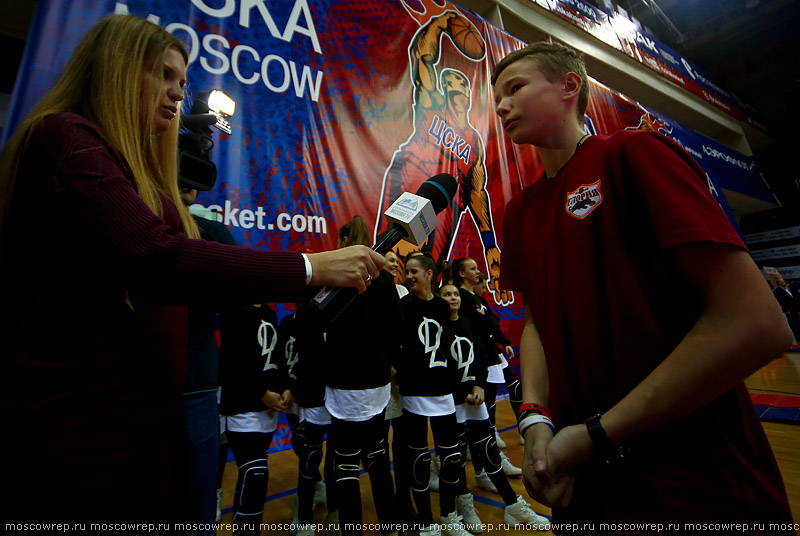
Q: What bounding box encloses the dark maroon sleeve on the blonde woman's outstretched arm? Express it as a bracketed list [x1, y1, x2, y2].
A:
[39, 114, 307, 303]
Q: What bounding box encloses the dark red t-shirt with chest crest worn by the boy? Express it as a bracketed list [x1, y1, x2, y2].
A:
[501, 131, 790, 521]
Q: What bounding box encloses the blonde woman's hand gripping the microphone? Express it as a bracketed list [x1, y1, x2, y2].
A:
[306, 246, 386, 292]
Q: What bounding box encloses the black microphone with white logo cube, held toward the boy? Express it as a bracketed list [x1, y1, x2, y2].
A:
[311, 173, 458, 322]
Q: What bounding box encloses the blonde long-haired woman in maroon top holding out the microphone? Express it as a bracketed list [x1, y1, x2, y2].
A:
[0, 15, 383, 522]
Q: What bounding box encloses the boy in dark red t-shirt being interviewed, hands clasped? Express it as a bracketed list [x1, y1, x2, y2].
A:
[492, 43, 792, 532]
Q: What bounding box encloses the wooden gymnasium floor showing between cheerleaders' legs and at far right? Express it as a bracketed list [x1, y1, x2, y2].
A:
[217, 353, 800, 536]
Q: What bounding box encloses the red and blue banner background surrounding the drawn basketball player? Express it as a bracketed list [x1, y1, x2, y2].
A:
[3, 0, 774, 354]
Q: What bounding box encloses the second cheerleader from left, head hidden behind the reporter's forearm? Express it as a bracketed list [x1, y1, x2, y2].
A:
[278, 305, 339, 536]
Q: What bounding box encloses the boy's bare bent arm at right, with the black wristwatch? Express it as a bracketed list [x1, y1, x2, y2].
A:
[544, 243, 792, 474]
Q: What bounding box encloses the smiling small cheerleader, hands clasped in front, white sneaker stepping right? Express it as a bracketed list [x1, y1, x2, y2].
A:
[439, 284, 548, 534]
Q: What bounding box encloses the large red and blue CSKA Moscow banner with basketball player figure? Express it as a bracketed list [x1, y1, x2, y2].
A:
[4, 0, 772, 343]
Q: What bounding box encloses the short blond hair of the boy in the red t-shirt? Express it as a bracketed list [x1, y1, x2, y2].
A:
[492, 41, 589, 123]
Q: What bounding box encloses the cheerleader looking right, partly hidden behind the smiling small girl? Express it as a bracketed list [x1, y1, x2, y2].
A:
[452, 257, 522, 484]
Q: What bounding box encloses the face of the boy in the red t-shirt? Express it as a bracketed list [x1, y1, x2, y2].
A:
[494, 58, 573, 147]
